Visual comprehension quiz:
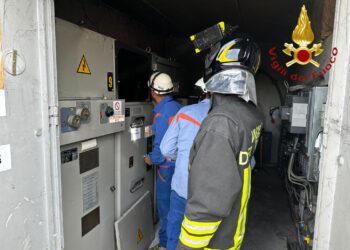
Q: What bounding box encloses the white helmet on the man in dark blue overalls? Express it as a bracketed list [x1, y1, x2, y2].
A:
[148, 72, 174, 95]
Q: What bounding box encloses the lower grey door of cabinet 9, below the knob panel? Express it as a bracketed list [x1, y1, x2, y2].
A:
[61, 135, 115, 250]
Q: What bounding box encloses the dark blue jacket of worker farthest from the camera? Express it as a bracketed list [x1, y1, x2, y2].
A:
[149, 96, 181, 166]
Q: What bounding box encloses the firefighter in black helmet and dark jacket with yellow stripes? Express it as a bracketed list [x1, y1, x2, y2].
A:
[177, 35, 262, 250]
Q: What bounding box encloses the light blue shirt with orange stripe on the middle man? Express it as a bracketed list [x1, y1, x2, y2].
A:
[160, 99, 210, 199]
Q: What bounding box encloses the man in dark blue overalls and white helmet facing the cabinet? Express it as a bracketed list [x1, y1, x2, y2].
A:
[144, 72, 181, 249]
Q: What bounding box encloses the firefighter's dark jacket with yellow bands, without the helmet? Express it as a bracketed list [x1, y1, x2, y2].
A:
[177, 94, 262, 250]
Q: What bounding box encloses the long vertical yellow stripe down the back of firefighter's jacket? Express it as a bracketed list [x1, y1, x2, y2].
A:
[232, 166, 251, 250]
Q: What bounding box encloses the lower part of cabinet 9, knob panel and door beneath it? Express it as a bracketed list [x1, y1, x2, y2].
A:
[60, 100, 125, 250]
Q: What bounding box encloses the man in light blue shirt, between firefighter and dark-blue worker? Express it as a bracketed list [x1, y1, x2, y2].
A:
[160, 78, 210, 250]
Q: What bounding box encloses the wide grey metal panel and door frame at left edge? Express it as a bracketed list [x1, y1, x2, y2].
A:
[0, 0, 63, 250]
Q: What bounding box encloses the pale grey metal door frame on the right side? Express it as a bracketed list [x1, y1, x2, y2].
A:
[313, 0, 350, 247]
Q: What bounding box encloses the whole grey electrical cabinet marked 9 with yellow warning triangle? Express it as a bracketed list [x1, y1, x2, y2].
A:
[56, 19, 125, 250]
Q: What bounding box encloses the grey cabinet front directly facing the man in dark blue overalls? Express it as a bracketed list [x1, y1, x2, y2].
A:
[115, 102, 154, 218]
